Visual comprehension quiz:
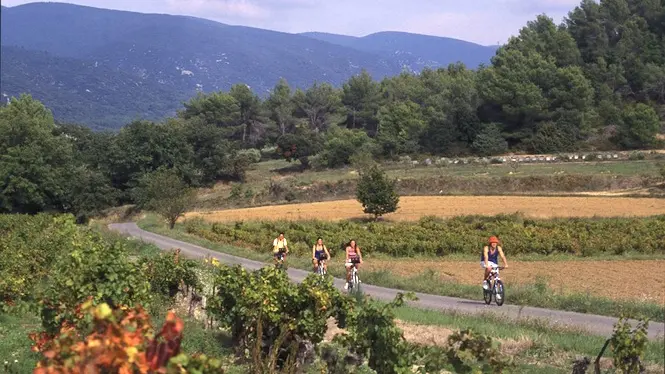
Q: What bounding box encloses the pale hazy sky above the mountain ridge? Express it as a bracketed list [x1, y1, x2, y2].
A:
[2, 0, 580, 45]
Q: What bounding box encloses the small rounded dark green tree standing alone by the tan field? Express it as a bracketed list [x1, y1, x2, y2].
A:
[356, 165, 399, 220]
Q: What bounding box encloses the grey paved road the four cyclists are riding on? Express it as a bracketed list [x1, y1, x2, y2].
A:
[109, 223, 665, 340]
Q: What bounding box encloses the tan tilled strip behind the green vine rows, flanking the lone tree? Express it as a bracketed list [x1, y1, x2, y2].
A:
[185, 196, 665, 222]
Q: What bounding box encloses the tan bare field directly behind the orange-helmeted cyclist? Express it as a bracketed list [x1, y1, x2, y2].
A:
[363, 254, 665, 305]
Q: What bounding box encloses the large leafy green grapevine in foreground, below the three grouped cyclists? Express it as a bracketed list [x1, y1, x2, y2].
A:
[206, 265, 349, 366]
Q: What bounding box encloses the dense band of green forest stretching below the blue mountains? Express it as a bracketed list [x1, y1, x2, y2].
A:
[0, 0, 665, 218]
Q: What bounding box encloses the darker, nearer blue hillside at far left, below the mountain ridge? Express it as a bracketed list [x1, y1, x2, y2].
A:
[0, 46, 184, 129]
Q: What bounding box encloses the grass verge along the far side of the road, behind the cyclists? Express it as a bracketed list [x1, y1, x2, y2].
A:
[137, 215, 665, 321]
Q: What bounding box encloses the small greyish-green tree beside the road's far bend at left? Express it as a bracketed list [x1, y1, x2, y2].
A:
[134, 169, 196, 230]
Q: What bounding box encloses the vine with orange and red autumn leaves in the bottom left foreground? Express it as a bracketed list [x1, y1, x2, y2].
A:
[31, 302, 222, 374]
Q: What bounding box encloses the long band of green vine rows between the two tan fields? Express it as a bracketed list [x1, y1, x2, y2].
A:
[185, 215, 665, 257]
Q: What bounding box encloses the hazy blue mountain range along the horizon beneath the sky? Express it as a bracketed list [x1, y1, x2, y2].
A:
[0, 3, 497, 128]
